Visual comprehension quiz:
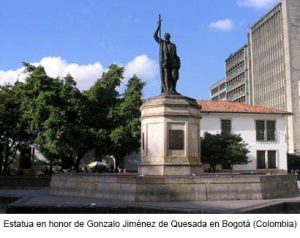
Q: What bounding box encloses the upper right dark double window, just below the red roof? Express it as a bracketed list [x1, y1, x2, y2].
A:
[256, 120, 276, 141]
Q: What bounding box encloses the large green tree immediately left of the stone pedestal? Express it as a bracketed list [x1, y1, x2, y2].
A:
[85, 65, 144, 164]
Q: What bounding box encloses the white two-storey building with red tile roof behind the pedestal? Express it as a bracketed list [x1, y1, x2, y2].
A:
[198, 101, 291, 172]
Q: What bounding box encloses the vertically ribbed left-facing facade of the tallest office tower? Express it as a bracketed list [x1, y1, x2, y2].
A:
[248, 4, 287, 110]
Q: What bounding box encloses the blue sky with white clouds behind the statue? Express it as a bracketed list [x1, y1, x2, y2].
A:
[0, 0, 278, 99]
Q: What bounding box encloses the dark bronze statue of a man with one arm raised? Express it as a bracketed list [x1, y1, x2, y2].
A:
[154, 16, 180, 94]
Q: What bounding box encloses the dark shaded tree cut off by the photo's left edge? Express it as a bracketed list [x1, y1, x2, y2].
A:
[0, 83, 29, 175]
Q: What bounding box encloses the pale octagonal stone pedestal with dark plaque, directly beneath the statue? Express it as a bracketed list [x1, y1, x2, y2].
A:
[139, 95, 203, 175]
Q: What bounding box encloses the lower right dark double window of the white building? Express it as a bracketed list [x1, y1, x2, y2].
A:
[256, 150, 277, 169]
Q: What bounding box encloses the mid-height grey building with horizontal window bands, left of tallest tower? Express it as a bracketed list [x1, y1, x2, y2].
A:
[225, 45, 250, 103]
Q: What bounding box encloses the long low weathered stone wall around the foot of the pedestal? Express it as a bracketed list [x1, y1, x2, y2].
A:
[49, 174, 298, 201]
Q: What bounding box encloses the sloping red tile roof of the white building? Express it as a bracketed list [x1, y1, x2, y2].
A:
[198, 100, 292, 115]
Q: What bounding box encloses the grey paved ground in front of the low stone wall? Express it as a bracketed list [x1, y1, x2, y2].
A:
[0, 188, 300, 213]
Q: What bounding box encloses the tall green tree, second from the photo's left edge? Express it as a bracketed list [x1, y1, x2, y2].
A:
[22, 63, 66, 170]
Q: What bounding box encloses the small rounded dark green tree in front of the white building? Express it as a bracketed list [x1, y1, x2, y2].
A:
[201, 132, 250, 172]
